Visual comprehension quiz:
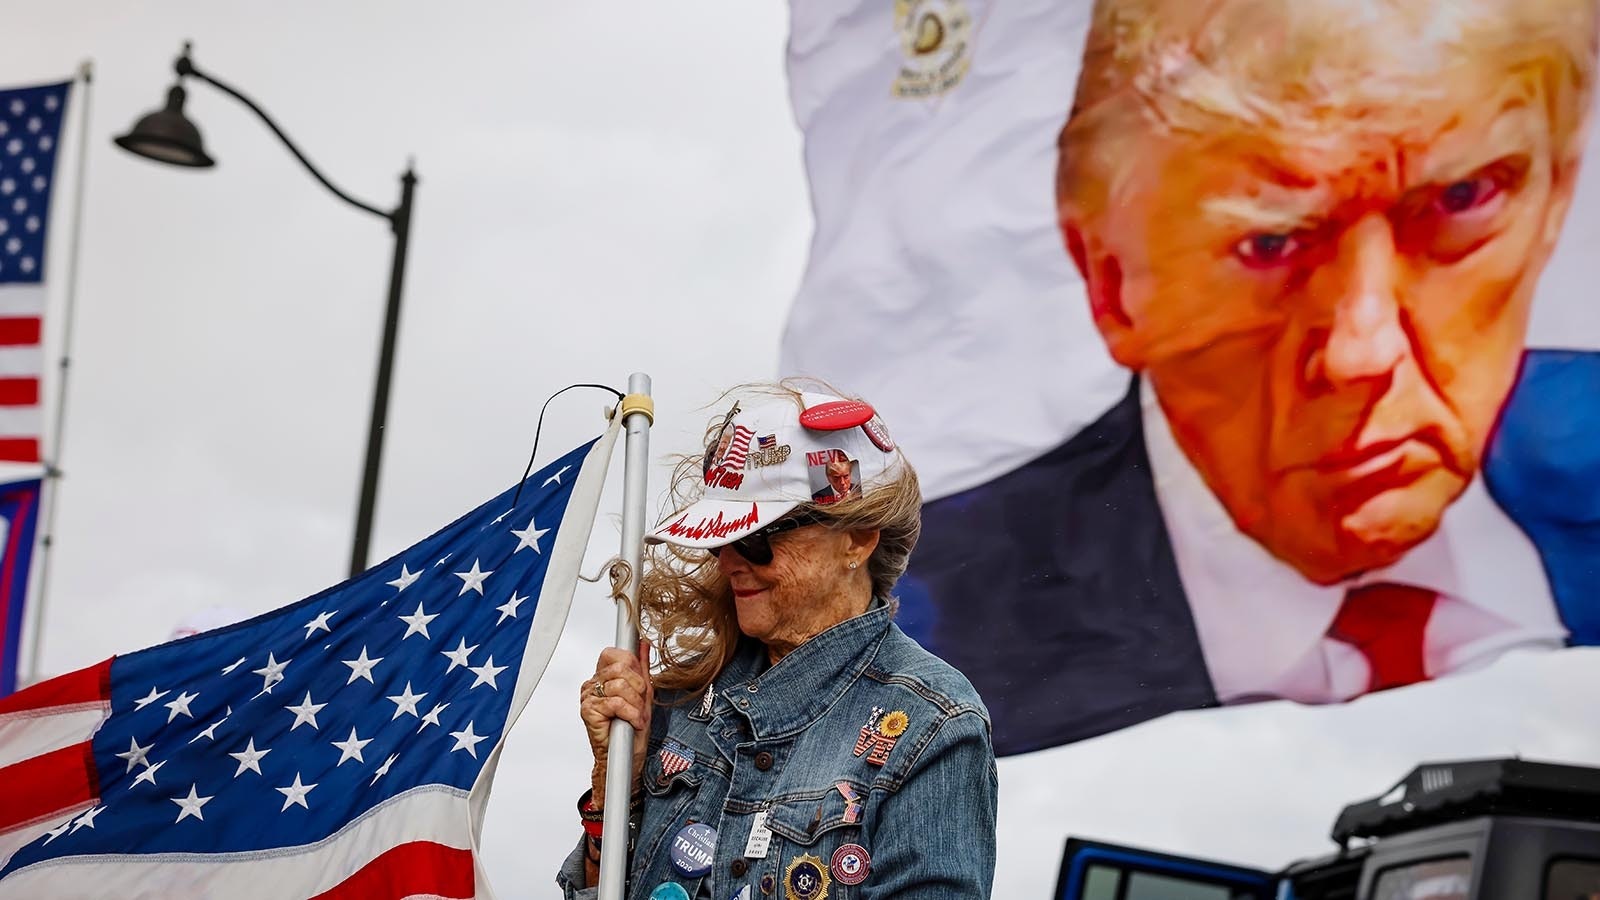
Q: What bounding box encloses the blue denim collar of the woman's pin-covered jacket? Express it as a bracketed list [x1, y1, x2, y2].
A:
[717, 599, 894, 740]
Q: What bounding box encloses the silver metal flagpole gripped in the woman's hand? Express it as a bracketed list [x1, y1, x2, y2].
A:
[598, 372, 656, 900]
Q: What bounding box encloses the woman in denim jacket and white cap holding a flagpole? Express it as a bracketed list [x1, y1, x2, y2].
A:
[557, 386, 995, 900]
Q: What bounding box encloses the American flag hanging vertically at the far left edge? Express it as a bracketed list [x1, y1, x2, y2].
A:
[0, 82, 72, 463]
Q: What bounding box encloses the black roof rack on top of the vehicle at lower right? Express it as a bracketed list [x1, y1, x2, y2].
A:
[1333, 759, 1600, 846]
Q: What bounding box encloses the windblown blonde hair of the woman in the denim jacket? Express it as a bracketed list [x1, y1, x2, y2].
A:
[638, 380, 922, 693]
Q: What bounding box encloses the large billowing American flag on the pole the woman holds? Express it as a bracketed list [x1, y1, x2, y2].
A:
[0, 426, 616, 898]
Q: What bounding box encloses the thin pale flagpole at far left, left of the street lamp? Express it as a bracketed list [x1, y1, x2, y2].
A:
[27, 59, 94, 684]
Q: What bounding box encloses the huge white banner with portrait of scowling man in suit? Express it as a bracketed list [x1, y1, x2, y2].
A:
[781, 0, 1600, 753]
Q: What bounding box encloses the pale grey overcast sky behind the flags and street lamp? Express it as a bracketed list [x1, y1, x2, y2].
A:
[0, 0, 1600, 898]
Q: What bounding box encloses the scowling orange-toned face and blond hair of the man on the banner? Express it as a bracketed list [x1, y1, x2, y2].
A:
[1058, 0, 1595, 583]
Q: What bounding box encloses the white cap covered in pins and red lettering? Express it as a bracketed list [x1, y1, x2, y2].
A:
[645, 392, 901, 548]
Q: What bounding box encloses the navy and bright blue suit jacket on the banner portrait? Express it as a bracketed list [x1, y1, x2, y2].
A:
[898, 351, 1600, 754]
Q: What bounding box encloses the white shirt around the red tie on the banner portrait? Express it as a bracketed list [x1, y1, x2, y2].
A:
[1139, 381, 1566, 703]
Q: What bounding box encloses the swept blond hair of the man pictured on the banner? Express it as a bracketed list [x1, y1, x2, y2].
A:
[1056, 0, 1600, 218]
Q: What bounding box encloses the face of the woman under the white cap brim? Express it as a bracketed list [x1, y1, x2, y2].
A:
[715, 525, 877, 652]
